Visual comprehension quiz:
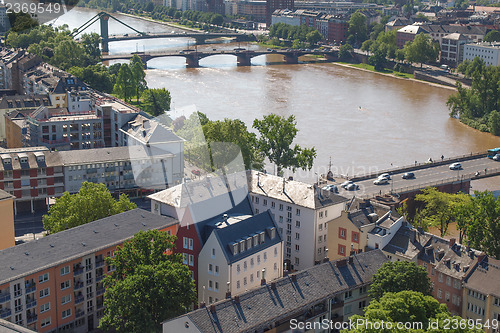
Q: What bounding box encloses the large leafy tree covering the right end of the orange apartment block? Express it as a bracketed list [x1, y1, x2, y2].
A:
[99, 230, 196, 333]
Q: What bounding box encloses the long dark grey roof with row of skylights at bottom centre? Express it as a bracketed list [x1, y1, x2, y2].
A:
[163, 250, 387, 333]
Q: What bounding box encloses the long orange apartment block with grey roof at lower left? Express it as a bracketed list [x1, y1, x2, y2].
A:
[0, 209, 178, 333]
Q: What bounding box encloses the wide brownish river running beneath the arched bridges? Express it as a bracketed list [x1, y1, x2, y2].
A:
[50, 8, 500, 189]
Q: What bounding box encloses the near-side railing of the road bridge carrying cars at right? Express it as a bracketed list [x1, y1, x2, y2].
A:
[358, 167, 500, 199]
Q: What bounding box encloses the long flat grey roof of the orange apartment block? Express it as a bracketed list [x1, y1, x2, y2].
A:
[0, 208, 178, 285]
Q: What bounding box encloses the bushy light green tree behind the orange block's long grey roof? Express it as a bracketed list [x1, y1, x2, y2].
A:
[43, 182, 137, 234]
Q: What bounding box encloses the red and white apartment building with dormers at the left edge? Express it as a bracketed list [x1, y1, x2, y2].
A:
[0, 147, 64, 215]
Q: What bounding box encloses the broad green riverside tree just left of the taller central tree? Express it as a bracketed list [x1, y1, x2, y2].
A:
[203, 118, 264, 170]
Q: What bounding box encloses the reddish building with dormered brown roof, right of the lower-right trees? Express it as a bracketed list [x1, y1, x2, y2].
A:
[418, 236, 485, 316]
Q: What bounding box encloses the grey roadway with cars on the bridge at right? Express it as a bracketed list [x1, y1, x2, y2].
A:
[339, 157, 500, 197]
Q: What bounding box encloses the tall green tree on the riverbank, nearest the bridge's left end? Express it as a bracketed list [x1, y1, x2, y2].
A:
[253, 114, 316, 175]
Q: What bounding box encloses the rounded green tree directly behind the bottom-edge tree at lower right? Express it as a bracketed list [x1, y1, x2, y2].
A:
[370, 261, 432, 299]
